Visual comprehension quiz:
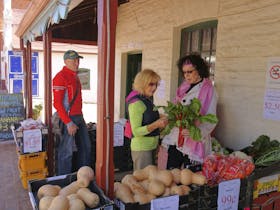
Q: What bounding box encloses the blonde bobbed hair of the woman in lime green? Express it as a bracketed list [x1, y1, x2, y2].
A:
[133, 69, 160, 95]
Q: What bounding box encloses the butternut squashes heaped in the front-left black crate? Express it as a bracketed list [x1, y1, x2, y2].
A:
[37, 166, 100, 210]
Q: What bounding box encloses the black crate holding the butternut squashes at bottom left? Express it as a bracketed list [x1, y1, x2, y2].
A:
[28, 173, 114, 210]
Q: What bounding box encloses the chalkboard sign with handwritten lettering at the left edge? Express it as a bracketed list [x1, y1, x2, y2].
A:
[0, 93, 25, 141]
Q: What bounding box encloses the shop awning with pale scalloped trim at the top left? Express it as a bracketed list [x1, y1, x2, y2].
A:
[16, 0, 83, 43]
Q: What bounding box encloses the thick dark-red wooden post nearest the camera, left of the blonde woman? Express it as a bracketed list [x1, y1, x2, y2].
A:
[96, 0, 118, 198]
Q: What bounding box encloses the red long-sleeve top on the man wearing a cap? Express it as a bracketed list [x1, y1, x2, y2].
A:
[53, 66, 82, 124]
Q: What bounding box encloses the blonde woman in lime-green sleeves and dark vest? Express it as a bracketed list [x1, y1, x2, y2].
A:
[126, 69, 168, 170]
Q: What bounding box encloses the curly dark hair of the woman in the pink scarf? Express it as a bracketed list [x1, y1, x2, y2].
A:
[177, 53, 210, 78]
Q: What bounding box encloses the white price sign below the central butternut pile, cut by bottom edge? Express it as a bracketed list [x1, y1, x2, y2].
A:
[151, 195, 179, 210]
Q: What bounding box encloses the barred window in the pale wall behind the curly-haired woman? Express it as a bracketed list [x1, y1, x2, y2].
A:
[179, 20, 218, 83]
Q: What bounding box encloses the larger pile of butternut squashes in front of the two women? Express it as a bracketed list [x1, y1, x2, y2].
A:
[114, 165, 207, 204]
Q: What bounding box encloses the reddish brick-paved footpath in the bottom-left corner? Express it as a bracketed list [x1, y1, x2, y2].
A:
[0, 140, 32, 210]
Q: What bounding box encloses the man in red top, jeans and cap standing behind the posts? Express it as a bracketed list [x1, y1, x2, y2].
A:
[53, 50, 91, 175]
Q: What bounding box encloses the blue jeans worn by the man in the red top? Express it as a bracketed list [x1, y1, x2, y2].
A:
[57, 115, 91, 175]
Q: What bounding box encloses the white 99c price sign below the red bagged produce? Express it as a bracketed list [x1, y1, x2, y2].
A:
[218, 179, 240, 210]
